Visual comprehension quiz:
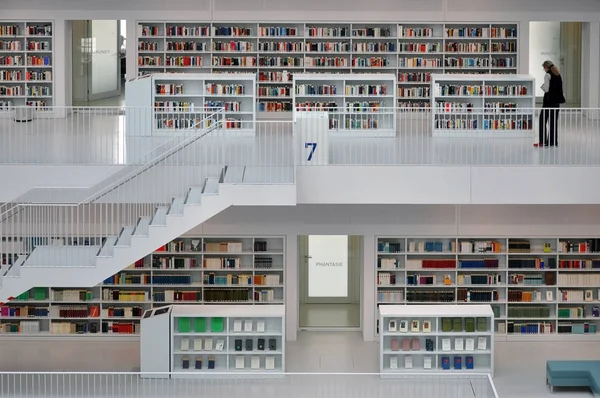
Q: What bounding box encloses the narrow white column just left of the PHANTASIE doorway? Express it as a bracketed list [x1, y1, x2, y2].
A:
[285, 235, 299, 341]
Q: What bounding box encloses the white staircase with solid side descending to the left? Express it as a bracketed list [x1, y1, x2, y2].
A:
[0, 177, 296, 302]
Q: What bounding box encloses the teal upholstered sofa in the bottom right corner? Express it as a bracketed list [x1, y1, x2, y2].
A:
[546, 360, 600, 396]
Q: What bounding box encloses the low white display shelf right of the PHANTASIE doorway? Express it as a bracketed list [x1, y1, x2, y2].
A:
[379, 305, 494, 377]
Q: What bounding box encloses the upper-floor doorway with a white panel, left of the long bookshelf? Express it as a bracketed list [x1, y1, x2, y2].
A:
[71, 20, 126, 107]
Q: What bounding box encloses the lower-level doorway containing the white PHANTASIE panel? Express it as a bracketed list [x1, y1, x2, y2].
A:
[298, 235, 363, 330]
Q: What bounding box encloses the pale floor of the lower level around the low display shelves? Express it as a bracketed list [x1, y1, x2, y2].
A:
[0, 332, 600, 398]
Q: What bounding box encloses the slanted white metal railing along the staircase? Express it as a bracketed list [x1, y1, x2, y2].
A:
[0, 109, 226, 275]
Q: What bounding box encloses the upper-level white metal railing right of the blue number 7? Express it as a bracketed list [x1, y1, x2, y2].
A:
[296, 108, 600, 166]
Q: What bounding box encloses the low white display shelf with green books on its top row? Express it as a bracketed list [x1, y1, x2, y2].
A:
[169, 305, 285, 378]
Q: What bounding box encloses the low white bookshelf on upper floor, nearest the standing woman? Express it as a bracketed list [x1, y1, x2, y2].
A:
[431, 74, 535, 137]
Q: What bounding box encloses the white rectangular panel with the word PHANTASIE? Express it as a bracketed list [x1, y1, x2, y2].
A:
[308, 235, 348, 297]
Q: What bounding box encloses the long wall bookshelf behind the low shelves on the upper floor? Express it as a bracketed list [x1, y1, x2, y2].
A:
[137, 21, 519, 118]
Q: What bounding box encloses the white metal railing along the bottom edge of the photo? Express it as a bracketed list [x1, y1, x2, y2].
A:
[0, 372, 498, 398]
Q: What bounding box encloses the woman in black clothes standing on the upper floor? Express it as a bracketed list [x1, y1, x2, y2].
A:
[533, 61, 565, 147]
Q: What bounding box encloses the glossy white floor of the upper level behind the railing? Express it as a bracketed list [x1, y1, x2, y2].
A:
[0, 112, 600, 167]
